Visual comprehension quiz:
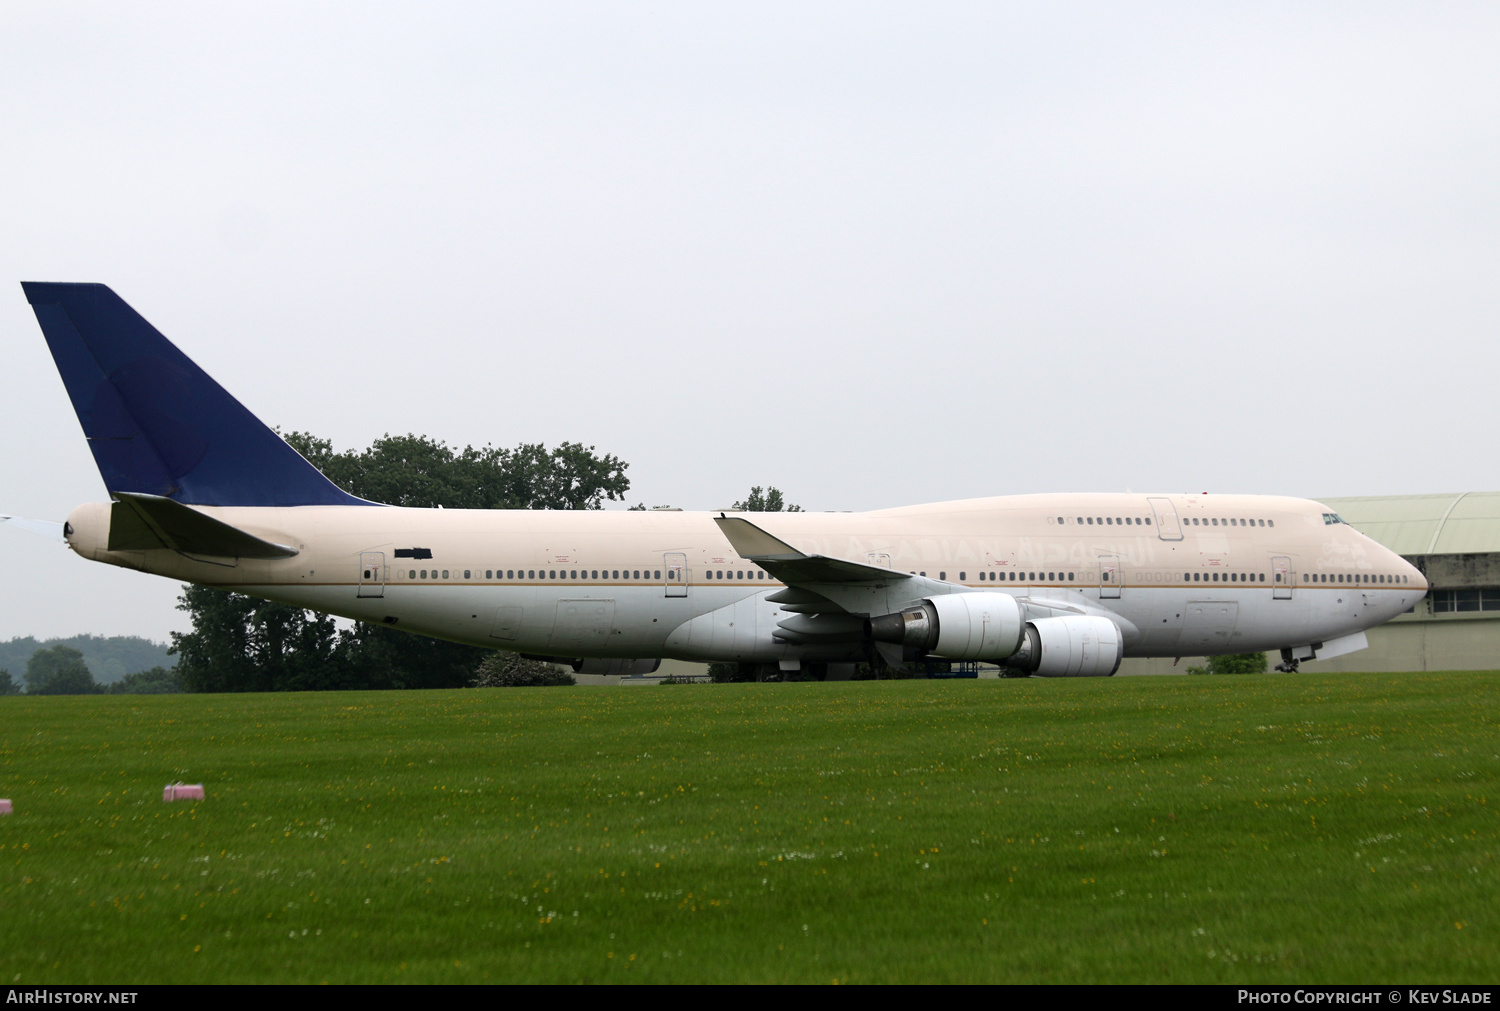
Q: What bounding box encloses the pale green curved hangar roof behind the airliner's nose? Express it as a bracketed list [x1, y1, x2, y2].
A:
[1317, 492, 1500, 555]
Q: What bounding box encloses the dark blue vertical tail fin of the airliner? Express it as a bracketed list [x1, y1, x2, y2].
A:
[21, 282, 372, 506]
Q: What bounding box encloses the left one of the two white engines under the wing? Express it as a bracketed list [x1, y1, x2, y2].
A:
[867, 593, 1026, 660]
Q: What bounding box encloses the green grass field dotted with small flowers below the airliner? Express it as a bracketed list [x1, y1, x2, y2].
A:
[0, 674, 1500, 984]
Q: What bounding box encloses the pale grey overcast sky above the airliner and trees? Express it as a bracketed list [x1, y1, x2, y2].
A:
[0, 0, 1500, 639]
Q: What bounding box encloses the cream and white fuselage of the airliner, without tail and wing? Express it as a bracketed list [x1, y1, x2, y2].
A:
[69, 494, 1427, 662]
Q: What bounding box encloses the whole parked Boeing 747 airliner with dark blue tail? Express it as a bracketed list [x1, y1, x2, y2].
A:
[23, 282, 1427, 677]
